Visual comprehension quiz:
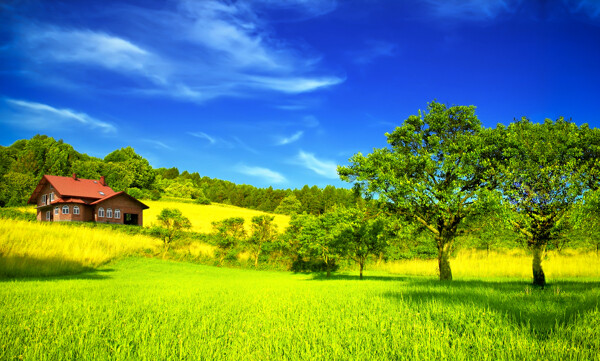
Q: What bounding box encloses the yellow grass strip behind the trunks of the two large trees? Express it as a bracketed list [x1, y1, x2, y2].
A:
[374, 250, 600, 279]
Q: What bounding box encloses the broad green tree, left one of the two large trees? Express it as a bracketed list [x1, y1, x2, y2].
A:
[338, 102, 495, 280]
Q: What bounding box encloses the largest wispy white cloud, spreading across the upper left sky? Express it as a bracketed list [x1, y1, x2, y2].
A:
[14, 0, 345, 102]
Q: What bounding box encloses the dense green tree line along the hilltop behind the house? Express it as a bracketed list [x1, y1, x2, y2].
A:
[0, 135, 356, 214]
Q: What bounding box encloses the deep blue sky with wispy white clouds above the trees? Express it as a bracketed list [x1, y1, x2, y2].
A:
[0, 0, 600, 188]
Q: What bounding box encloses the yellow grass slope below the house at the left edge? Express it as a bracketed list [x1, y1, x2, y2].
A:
[0, 219, 161, 276]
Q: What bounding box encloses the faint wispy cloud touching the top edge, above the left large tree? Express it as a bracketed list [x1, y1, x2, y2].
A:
[425, 0, 522, 21]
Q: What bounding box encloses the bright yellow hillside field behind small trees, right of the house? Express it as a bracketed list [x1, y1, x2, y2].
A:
[144, 200, 290, 233]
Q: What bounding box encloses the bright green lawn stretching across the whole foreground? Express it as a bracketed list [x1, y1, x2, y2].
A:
[0, 258, 600, 360]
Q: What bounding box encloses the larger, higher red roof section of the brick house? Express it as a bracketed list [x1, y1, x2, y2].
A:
[28, 175, 116, 204]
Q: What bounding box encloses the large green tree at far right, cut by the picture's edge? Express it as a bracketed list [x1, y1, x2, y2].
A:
[495, 118, 600, 287]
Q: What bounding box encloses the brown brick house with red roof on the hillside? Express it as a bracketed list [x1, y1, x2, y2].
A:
[27, 174, 148, 226]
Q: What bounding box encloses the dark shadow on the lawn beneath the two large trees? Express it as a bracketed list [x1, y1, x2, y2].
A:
[383, 280, 600, 340]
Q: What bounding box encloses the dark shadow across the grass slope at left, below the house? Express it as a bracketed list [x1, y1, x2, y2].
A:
[0, 256, 114, 282]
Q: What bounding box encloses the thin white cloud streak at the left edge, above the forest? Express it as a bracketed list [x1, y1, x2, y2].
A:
[4, 98, 116, 133]
